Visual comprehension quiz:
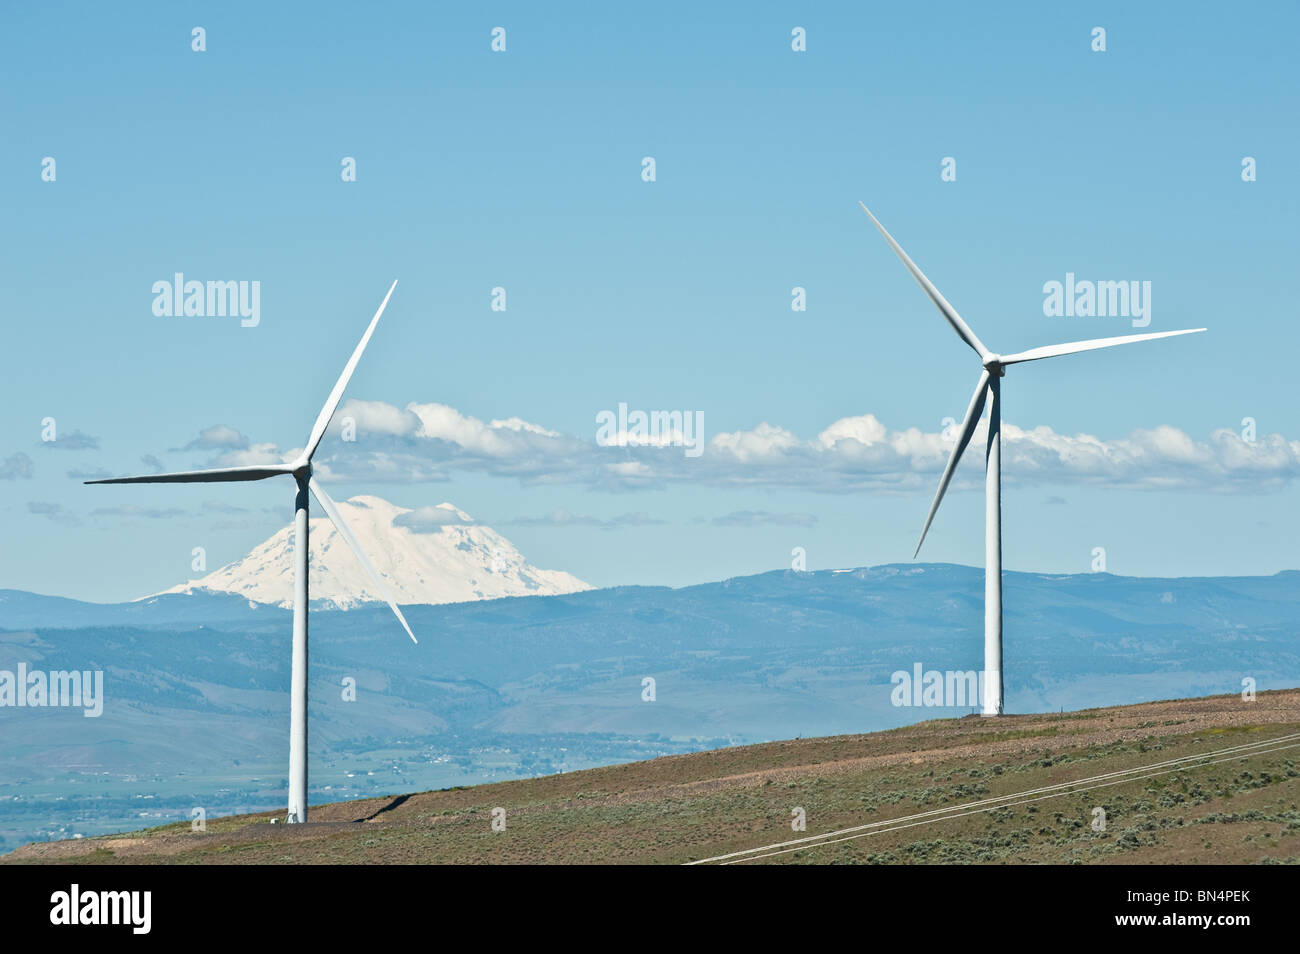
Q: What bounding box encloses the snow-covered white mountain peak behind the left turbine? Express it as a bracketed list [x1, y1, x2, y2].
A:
[155, 496, 592, 610]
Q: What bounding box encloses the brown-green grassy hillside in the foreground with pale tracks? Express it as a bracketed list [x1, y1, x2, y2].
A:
[3, 690, 1300, 864]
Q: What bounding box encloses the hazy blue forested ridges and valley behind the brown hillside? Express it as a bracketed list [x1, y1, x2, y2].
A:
[0, 561, 1300, 847]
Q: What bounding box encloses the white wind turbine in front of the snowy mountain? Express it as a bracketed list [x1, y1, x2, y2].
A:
[86, 282, 419, 823]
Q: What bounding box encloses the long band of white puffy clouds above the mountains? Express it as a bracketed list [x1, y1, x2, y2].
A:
[147, 400, 1300, 496]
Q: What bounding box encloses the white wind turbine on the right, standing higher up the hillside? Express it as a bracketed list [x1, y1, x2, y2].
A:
[858, 201, 1205, 716]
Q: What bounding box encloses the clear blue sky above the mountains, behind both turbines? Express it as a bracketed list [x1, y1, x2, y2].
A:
[0, 4, 1300, 599]
